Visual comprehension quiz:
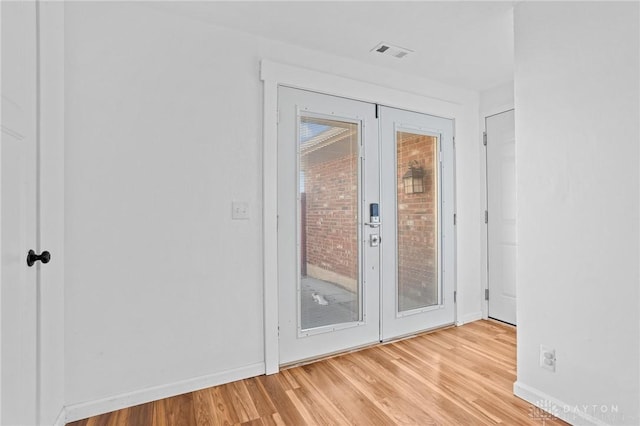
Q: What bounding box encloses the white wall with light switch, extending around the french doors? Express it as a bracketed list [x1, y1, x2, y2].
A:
[65, 2, 481, 420]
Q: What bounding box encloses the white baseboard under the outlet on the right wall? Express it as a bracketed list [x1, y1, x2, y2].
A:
[513, 382, 635, 426]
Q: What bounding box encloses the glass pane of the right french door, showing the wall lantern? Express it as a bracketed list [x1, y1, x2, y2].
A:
[396, 131, 440, 312]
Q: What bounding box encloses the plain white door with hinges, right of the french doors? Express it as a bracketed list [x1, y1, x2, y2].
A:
[485, 110, 517, 325]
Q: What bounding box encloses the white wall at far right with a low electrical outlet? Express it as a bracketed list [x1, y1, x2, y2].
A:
[515, 2, 640, 425]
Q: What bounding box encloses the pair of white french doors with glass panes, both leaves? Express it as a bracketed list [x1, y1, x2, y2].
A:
[278, 87, 455, 364]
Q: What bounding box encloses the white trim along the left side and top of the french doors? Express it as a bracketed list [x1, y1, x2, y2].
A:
[260, 59, 465, 374]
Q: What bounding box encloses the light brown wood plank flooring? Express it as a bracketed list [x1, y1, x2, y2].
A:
[70, 321, 565, 426]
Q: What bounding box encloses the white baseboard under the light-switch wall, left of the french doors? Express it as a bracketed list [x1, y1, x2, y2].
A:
[65, 362, 265, 426]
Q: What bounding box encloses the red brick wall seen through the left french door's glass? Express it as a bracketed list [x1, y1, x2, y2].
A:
[303, 154, 358, 287]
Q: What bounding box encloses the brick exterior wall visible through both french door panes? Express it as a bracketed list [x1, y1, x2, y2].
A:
[302, 133, 438, 304]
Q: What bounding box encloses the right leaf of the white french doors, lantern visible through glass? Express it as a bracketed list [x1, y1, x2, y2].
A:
[380, 107, 455, 340]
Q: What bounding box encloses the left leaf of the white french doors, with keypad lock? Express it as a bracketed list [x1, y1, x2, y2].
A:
[278, 87, 380, 364]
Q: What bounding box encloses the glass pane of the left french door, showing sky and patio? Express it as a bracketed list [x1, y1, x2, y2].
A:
[298, 115, 362, 331]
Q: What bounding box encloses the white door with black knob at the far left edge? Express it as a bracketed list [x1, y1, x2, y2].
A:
[0, 1, 37, 425]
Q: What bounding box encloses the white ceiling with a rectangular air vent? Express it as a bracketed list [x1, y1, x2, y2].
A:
[152, 1, 513, 90]
